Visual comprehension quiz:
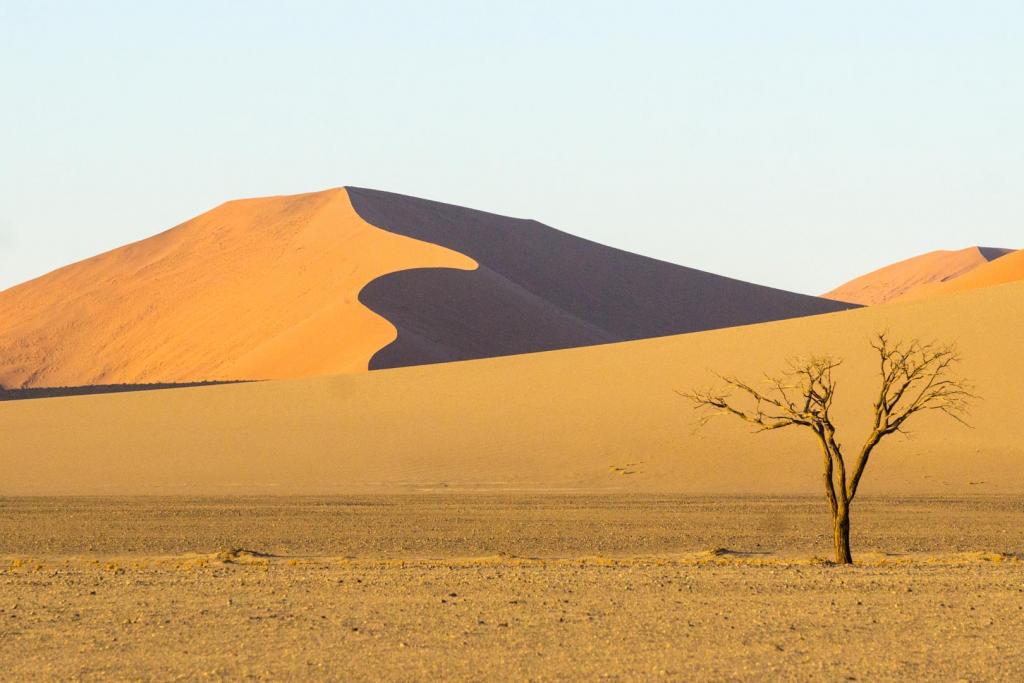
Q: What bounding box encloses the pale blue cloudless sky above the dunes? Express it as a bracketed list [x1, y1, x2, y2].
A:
[0, 0, 1024, 293]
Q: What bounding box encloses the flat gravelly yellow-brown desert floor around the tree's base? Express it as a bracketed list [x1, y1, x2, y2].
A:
[0, 494, 1024, 681]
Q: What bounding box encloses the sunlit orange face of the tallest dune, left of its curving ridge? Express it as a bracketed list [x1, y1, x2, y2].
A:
[0, 188, 476, 387]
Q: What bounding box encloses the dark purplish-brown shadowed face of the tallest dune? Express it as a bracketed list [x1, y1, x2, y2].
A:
[348, 187, 851, 369]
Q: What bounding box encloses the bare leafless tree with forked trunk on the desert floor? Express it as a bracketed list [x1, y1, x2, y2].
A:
[681, 333, 974, 564]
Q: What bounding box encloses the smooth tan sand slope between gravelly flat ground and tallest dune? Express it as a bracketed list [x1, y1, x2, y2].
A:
[0, 283, 1024, 495]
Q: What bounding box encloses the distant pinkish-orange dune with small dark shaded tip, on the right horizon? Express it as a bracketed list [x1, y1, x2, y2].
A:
[821, 247, 1012, 305]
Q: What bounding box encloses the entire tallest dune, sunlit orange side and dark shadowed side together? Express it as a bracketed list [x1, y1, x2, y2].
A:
[0, 188, 850, 395]
